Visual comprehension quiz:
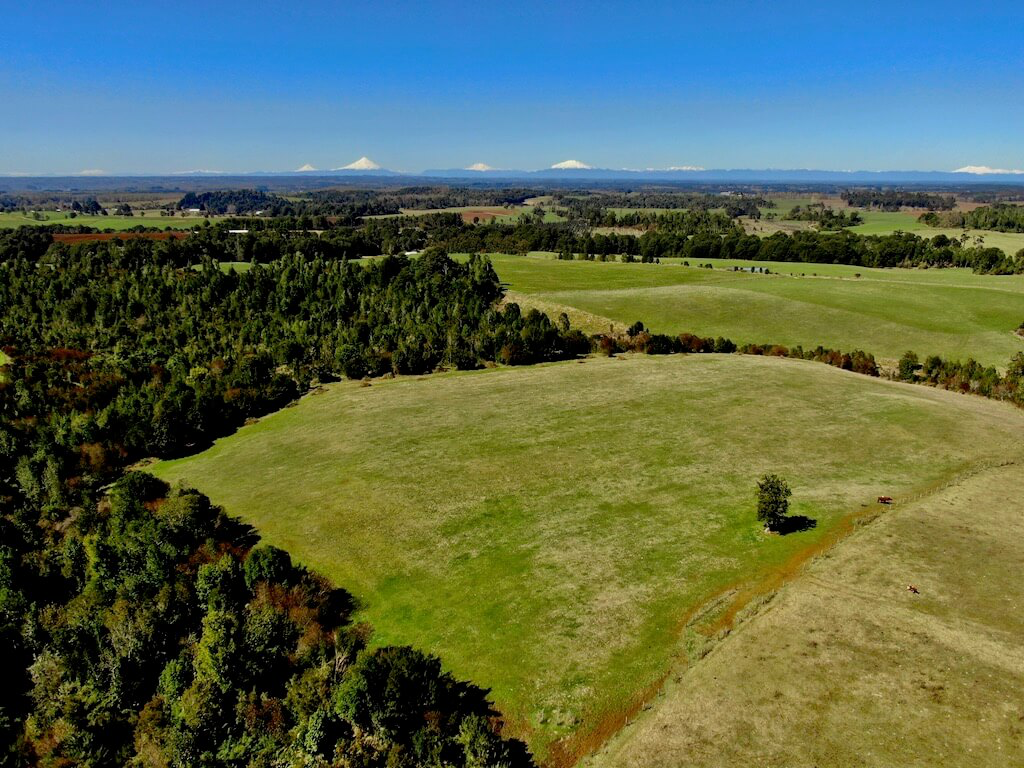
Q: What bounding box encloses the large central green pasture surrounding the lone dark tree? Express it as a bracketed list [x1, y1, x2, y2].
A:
[154, 355, 1024, 764]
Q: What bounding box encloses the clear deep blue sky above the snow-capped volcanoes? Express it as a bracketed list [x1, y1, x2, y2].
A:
[0, 0, 1024, 173]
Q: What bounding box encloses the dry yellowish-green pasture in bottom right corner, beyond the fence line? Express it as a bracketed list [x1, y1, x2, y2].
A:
[589, 456, 1024, 768]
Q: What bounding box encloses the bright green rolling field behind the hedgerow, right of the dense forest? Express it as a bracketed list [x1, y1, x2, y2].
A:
[493, 256, 1024, 367]
